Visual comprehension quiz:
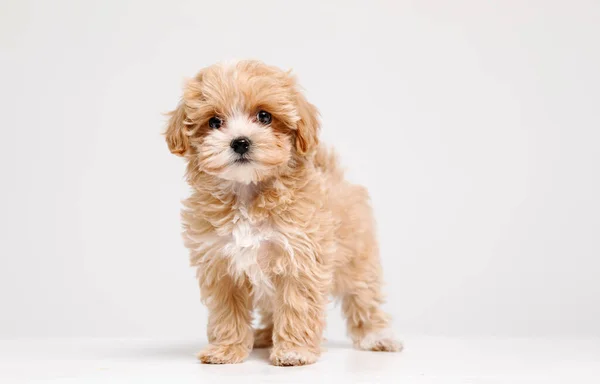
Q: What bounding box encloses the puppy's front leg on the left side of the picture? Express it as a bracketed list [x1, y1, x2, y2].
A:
[198, 263, 253, 364]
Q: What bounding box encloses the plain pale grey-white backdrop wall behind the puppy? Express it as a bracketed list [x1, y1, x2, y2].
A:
[0, 0, 600, 339]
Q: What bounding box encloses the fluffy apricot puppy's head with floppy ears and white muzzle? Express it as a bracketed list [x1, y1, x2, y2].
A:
[166, 61, 319, 183]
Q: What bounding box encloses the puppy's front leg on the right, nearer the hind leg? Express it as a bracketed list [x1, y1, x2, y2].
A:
[270, 263, 327, 366]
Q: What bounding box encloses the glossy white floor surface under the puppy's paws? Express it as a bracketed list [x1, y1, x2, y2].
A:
[0, 337, 600, 384]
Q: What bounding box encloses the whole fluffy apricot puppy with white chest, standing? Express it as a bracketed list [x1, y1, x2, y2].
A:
[165, 61, 401, 366]
